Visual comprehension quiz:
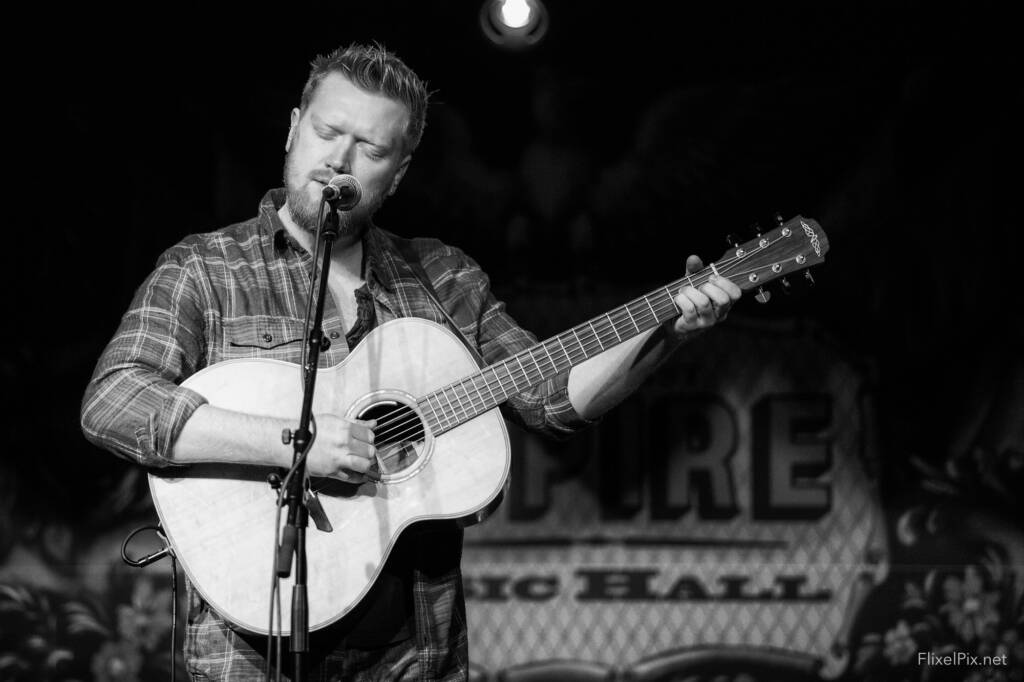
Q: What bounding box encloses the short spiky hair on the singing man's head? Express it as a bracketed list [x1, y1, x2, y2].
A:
[299, 43, 430, 153]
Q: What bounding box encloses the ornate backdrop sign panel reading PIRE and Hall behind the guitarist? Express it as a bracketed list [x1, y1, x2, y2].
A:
[464, 321, 885, 670]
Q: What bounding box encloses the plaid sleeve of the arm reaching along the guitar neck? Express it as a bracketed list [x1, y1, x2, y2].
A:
[438, 247, 595, 439]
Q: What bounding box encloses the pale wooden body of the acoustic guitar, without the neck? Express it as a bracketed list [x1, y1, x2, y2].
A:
[150, 318, 510, 634]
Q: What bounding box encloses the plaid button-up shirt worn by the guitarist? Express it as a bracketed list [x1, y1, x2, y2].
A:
[82, 189, 588, 679]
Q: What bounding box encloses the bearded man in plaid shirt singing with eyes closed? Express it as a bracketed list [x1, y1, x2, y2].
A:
[82, 45, 740, 680]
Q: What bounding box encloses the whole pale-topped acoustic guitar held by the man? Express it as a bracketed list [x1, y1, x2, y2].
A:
[150, 216, 828, 634]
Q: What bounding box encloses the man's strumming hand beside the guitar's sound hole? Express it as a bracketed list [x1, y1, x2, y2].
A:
[306, 414, 380, 483]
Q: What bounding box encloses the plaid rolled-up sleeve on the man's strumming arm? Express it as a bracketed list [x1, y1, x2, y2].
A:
[81, 246, 206, 467]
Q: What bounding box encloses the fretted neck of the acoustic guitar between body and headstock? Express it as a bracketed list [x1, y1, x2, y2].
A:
[418, 266, 714, 433]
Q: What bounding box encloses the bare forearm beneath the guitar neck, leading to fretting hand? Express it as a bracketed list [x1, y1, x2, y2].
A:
[568, 325, 692, 419]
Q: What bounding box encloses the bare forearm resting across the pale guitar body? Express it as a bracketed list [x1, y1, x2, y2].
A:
[171, 404, 293, 467]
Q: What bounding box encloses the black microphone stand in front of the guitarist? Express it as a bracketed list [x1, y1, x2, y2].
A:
[278, 202, 339, 682]
